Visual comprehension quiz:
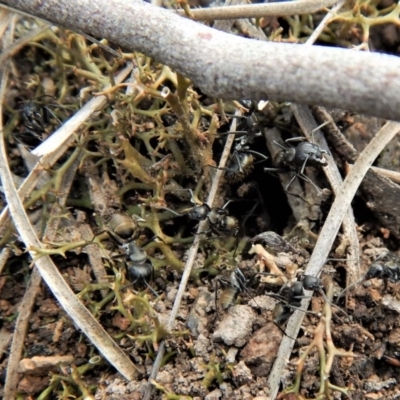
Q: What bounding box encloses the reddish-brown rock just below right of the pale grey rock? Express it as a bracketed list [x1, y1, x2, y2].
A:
[240, 322, 282, 377]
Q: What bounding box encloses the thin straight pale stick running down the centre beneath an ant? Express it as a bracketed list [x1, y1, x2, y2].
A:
[143, 112, 241, 400]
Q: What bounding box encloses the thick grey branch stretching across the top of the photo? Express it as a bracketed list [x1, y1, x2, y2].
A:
[0, 0, 400, 121]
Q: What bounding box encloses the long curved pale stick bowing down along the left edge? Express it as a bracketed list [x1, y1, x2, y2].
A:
[0, 85, 138, 380]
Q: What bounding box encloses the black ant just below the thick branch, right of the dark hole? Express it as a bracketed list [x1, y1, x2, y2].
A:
[264, 137, 327, 191]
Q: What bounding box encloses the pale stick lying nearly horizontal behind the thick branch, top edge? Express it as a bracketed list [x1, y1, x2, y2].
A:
[176, 0, 337, 21]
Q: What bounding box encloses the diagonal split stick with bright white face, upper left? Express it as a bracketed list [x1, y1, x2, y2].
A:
[0, 64, 133, 231]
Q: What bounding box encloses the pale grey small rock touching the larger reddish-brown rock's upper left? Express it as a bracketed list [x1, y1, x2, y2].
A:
[213, 305, 256, 347]
